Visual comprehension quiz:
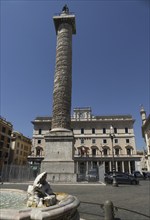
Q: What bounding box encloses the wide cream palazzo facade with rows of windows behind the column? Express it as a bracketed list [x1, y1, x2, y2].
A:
[28, 107, 140, 178]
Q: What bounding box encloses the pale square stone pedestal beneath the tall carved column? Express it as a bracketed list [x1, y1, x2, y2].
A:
[41, 129, 77, 182]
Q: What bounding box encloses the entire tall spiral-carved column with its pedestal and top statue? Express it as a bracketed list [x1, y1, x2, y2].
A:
[41, 5, 76, 182]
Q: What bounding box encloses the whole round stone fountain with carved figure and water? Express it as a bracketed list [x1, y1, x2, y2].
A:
[0, 172, 80, 220]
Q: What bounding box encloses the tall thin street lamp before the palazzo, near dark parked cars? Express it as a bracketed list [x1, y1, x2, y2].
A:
[110, 125, 118, 187]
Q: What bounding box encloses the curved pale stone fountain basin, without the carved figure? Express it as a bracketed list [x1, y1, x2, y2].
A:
[0, 189, 80, 220]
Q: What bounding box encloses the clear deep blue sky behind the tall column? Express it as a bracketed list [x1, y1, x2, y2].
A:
[0, 0, 150, 149]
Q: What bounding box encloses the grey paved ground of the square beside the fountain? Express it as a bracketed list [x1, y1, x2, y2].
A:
[0, 180, 150, 220]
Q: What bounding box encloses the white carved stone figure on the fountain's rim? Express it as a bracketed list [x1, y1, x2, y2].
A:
[27, 172, 56, 207]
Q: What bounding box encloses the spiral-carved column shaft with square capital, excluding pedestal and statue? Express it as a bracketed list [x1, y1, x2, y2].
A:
[52, 13, 75, 129]
